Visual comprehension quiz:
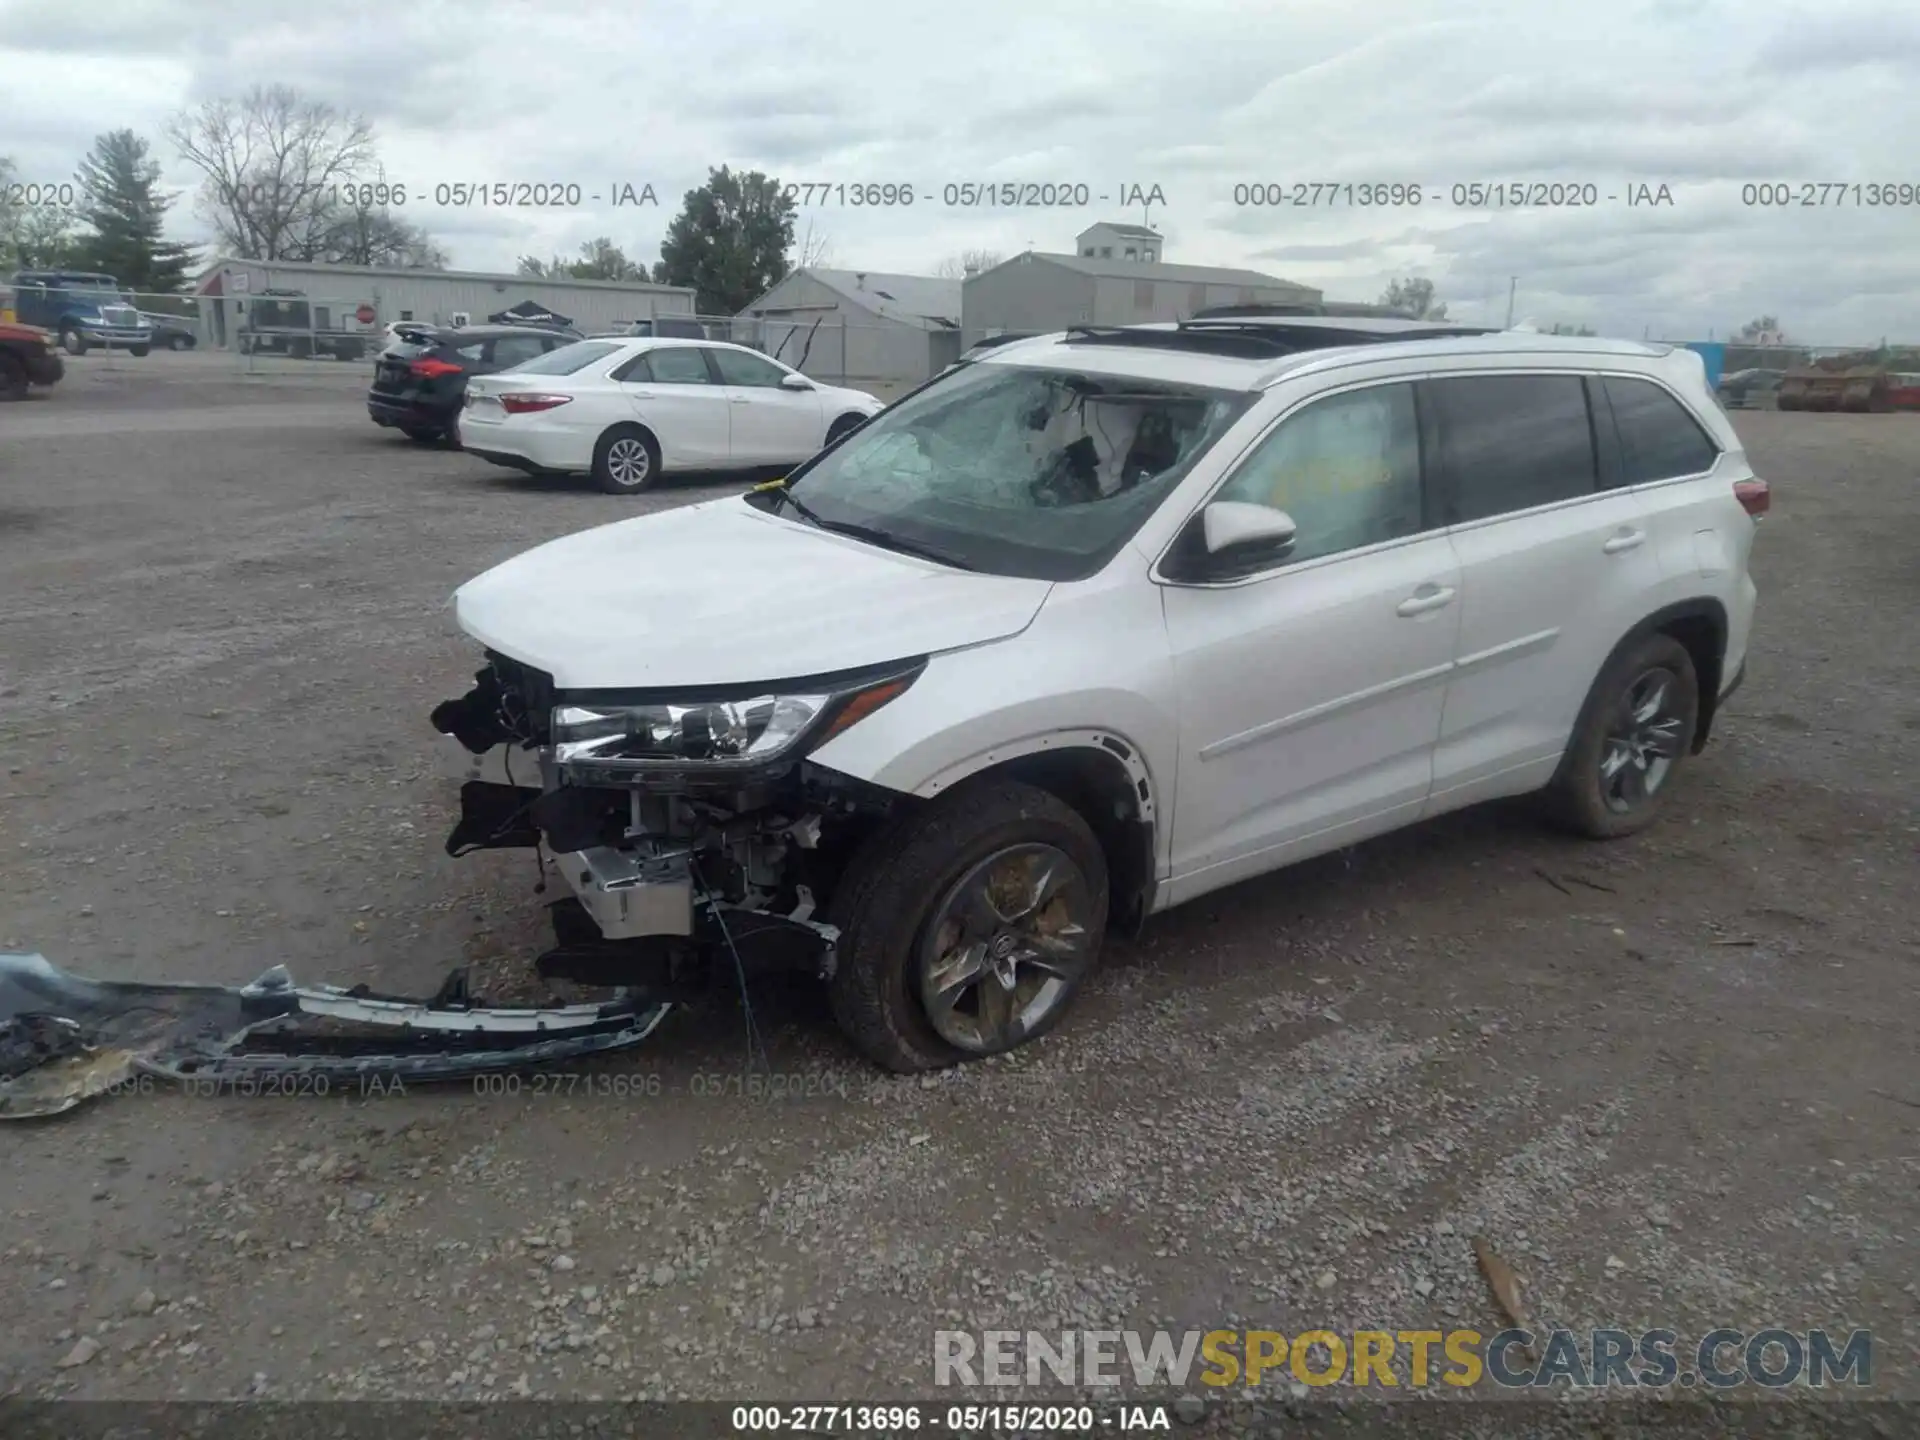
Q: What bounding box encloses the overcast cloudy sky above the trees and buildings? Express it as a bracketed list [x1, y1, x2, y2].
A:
[0, 0, 1920, 344]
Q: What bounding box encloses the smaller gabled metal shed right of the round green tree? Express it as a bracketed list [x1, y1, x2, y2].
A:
[735, 265, 960, 399]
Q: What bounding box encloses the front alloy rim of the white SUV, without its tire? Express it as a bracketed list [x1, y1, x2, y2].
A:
[918, 845, 1092, 1054]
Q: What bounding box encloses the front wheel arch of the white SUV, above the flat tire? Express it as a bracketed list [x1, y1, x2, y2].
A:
[916, 730, 1160, 933]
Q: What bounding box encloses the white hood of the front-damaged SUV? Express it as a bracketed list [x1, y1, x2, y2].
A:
[453, 495, 1052, 689]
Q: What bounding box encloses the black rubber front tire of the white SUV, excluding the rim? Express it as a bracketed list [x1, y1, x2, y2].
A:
[828, 780, 1108, 1075]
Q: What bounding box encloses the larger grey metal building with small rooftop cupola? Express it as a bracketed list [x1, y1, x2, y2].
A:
[962, 237, 1323, 346]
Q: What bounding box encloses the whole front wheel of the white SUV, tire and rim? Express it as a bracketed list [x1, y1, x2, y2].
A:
[829, 780, 1108, 1073]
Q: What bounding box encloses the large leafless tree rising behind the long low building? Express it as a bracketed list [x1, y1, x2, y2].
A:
[167, 84, 374, 261]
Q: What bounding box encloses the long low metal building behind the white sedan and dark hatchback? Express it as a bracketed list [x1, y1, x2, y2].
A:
[194, 255, 693, 348]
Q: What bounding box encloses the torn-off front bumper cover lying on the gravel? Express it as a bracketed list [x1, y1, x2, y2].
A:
[0, 954, 670, 1119]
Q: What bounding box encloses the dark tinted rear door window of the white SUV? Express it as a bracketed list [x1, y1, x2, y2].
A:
[1423, 374, 1599, 524]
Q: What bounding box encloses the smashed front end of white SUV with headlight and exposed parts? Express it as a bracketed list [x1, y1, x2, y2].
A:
[432, 651, 925, 1002]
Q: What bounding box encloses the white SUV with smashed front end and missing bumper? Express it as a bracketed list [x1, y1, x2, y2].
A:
[434, 319, 1768, 1071]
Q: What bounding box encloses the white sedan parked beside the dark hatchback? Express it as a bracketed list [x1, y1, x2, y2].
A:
[459, 338, 885, 495]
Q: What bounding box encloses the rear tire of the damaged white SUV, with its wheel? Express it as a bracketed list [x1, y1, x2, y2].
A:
[1546, 636, 1699, 839]
